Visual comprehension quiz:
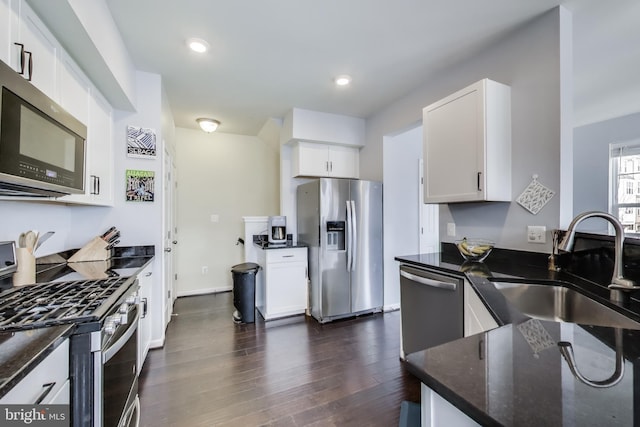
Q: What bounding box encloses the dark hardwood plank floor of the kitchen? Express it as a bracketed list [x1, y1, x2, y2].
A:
[140, 292, 420, 427]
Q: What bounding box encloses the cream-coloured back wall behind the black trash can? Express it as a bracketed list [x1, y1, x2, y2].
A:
[176, 128, 280, 296]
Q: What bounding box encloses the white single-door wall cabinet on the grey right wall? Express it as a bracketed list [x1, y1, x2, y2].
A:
[423, 79, 511, 203]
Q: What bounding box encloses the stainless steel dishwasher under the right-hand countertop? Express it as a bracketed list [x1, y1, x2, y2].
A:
[400, 264, 464, 359]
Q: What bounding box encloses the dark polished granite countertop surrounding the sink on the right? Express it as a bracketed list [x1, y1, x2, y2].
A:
[396, 244, 640, 426]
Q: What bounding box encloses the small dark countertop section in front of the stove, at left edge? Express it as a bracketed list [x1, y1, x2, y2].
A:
[0, 325, 75, 398]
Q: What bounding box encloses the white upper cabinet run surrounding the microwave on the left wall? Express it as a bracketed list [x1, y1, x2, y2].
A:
[0, 0, 113, 206]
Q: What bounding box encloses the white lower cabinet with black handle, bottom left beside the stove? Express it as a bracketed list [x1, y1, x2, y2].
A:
[0, 339, 70, 405]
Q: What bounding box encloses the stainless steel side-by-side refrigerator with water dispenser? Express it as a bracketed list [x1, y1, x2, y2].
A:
[297, 178, 383, 323]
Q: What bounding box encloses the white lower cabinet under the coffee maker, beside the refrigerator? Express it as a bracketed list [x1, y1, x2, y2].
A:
[256, 248, 308, 320]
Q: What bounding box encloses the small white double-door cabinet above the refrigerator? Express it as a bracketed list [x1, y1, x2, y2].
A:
[292, 142, 360, 178]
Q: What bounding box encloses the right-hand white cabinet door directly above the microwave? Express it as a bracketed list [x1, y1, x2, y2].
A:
[9, 0, 59, 101]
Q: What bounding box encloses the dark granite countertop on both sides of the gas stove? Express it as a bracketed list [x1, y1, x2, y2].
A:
[0, 246, 154, 397]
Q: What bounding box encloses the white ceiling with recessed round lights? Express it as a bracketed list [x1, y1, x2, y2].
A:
[107, 0, 640, 135]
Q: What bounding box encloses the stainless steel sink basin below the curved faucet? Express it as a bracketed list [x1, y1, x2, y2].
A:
[491, 281, 640, 330]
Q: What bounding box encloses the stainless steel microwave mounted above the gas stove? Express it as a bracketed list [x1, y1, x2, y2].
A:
[0, 61, 87, 197]
